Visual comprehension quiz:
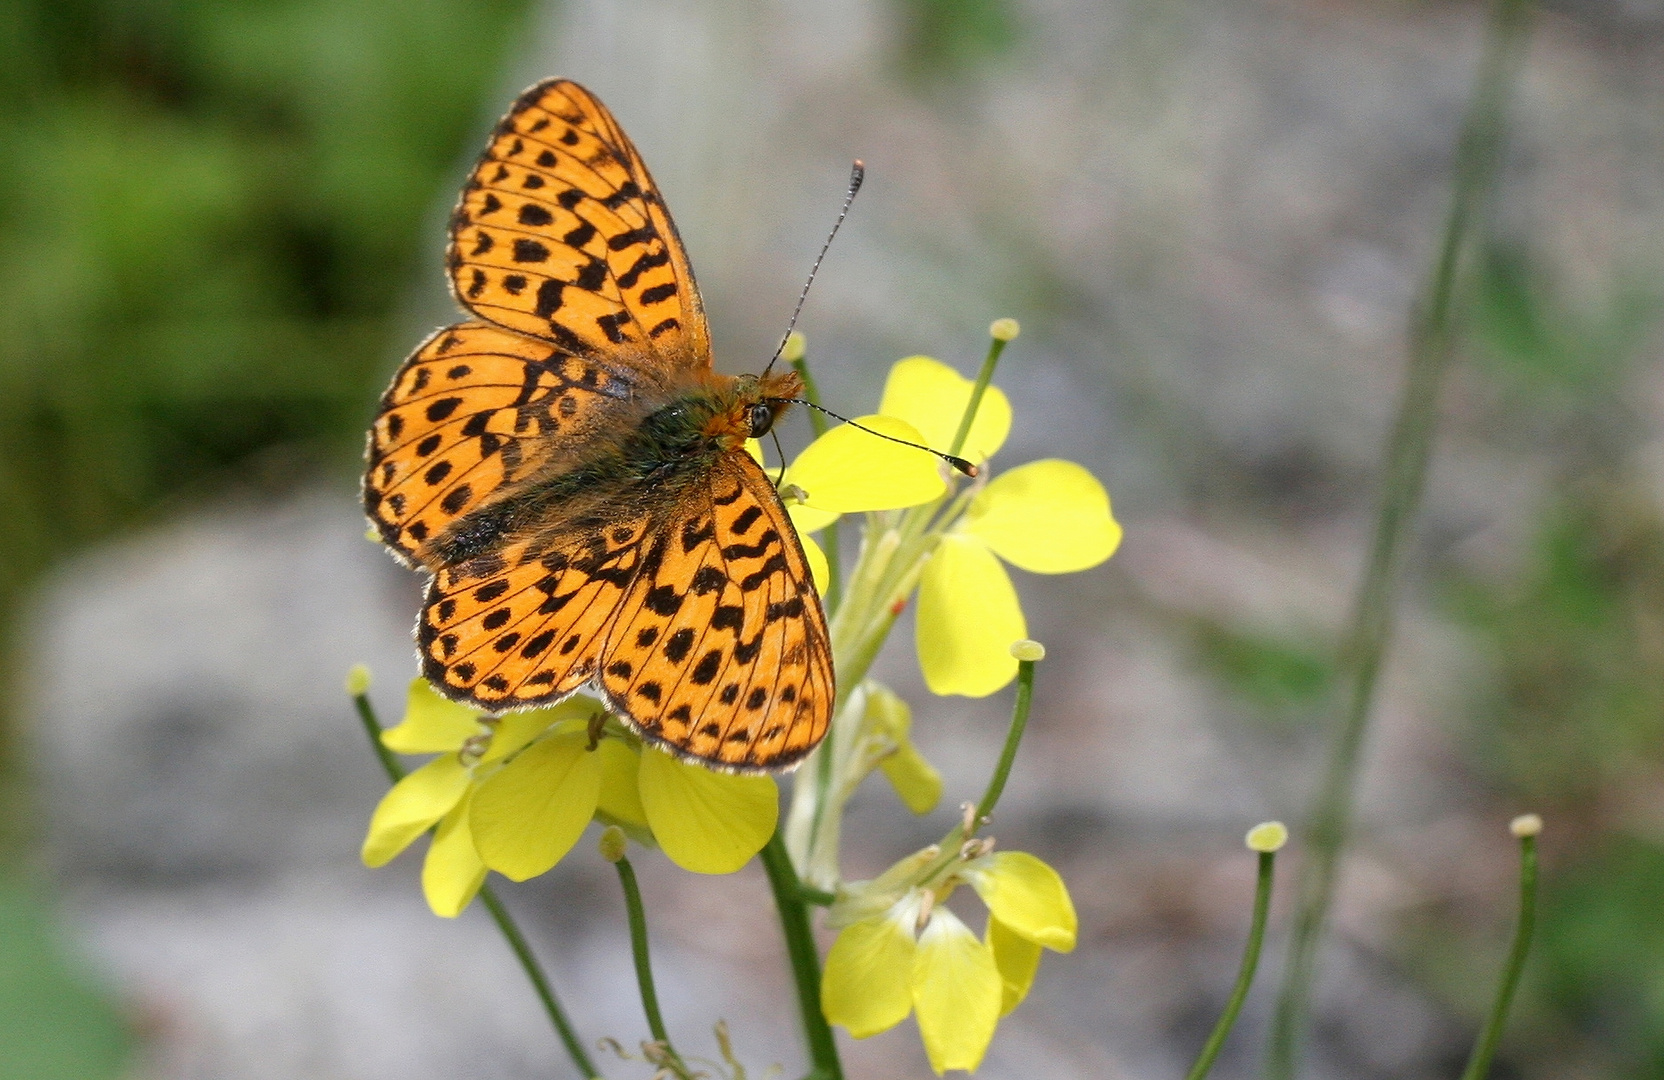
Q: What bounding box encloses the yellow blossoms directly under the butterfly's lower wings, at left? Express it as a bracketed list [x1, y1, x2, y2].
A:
[363, 679, 779, 917]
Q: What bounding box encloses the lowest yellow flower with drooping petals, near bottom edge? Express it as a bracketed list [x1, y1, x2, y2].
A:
[820, 849, 1077, 1075]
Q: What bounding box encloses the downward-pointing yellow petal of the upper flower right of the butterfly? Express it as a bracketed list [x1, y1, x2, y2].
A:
[915, 534, 1028, 697]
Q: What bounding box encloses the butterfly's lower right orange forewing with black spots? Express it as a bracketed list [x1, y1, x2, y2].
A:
[602, 453, 832, 767]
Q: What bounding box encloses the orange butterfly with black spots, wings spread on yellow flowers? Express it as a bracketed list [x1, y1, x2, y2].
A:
[363, 80, 834, 772]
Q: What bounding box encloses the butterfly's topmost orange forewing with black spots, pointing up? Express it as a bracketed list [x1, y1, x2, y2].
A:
[449, 80, 711, 366]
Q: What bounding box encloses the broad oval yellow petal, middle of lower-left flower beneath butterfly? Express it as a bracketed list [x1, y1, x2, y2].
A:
[469, 729, 601, 882]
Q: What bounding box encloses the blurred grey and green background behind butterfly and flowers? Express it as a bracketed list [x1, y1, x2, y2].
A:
[0, 0, 1664, 1080]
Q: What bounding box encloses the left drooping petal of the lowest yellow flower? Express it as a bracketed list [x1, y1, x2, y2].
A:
[820, 899, 919, 1038]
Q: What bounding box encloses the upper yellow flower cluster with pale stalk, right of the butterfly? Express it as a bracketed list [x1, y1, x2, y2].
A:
[782, 347, 1122, 890]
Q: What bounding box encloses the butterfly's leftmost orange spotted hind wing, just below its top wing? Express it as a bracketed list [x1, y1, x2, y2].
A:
[364, 323, 634, 561]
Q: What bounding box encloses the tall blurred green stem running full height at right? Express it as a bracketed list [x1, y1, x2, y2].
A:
[1266, 0, 1526, 1080]
